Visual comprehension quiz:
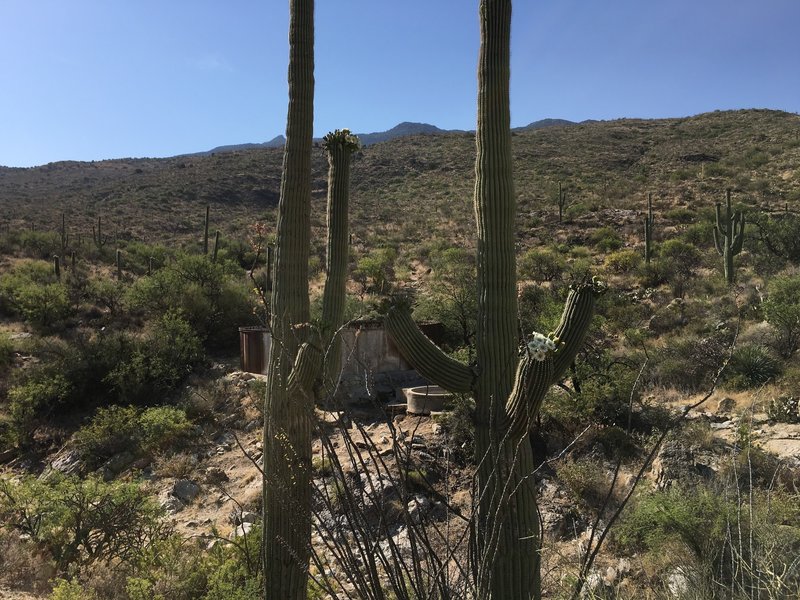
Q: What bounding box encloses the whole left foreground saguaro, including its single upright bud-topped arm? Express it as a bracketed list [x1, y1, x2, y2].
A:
[263, 0, 359, 600]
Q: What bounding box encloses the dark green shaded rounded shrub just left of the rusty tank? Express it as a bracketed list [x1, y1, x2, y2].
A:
[105, 311, 203, 404]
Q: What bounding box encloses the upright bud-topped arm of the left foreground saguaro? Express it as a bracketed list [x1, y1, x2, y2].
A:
[321, 129, 359, 390]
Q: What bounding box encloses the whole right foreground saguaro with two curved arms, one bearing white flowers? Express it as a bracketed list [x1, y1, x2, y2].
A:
[385, 0, 603, 600]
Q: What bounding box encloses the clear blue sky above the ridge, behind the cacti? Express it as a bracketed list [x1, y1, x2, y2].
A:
[0, 0, 800, 166]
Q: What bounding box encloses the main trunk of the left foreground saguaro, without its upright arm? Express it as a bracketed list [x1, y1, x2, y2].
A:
[263, 0, 314, 600]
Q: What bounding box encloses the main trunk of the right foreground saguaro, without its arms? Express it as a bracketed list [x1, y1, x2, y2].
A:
[475, 0, 540, 600]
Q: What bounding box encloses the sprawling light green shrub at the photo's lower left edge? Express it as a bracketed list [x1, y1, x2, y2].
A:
[0, 474, 168, 572]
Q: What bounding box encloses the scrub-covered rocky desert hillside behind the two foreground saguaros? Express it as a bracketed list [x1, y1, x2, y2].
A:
[0, 110, 800, 600]
